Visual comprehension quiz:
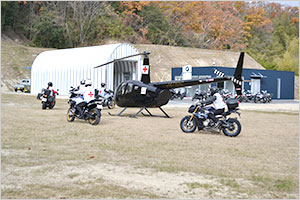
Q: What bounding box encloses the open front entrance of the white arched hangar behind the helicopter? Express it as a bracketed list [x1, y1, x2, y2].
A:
[113, 60, 138, 90]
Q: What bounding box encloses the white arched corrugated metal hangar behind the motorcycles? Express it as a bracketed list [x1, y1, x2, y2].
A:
[31, 44, 142, 95]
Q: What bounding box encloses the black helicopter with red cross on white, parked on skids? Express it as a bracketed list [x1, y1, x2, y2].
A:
[95, 52, 244, 118]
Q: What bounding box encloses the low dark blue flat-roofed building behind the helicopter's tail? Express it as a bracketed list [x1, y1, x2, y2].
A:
[172, 66, 295, 99]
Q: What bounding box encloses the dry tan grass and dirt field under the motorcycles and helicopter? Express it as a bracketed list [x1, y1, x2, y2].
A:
[1, 93, 299, 199]
